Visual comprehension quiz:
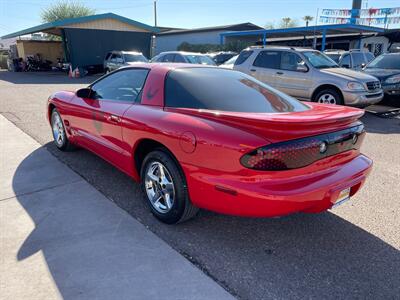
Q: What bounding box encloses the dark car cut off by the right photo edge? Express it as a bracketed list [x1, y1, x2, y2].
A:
[363, 53, 400, 97]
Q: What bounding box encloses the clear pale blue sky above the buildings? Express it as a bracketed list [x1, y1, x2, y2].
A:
[0, 0, 400, 36]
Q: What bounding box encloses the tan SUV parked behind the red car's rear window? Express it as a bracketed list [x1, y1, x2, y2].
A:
[233, 47, 383, 107]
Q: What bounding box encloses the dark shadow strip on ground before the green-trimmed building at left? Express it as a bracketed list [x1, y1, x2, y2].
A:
[0, 71, 101, 84]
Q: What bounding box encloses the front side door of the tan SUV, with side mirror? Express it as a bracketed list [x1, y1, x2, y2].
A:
[275, 51, 313, 98]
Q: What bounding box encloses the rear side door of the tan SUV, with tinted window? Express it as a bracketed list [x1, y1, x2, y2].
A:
[249, 50, 281, 87]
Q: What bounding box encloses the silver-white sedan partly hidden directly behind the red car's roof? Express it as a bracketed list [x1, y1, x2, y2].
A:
[151, 51, 215, 66]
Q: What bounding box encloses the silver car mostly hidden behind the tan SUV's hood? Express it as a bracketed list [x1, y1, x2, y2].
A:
[324, 49, 375, 71]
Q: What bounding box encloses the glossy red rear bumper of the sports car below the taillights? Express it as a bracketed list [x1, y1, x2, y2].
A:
[185, 151, 372, 217]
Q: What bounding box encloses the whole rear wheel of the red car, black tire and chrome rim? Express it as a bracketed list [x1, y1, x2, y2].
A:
[140, 149, 199, 224]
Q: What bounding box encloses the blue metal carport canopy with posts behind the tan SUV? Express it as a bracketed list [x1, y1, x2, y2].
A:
[220, 24, 385, 51]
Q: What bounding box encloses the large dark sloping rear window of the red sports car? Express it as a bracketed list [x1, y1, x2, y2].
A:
[165, 68, 308, 113]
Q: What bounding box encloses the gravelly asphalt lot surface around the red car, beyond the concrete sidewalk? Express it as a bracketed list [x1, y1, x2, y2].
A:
[0, 71, 400, 299]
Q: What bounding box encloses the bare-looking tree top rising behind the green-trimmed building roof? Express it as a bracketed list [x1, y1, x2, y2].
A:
[41, 0, 95, 23]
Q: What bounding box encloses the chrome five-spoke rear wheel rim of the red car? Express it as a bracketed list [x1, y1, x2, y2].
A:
[145, 161, 175, 214]
